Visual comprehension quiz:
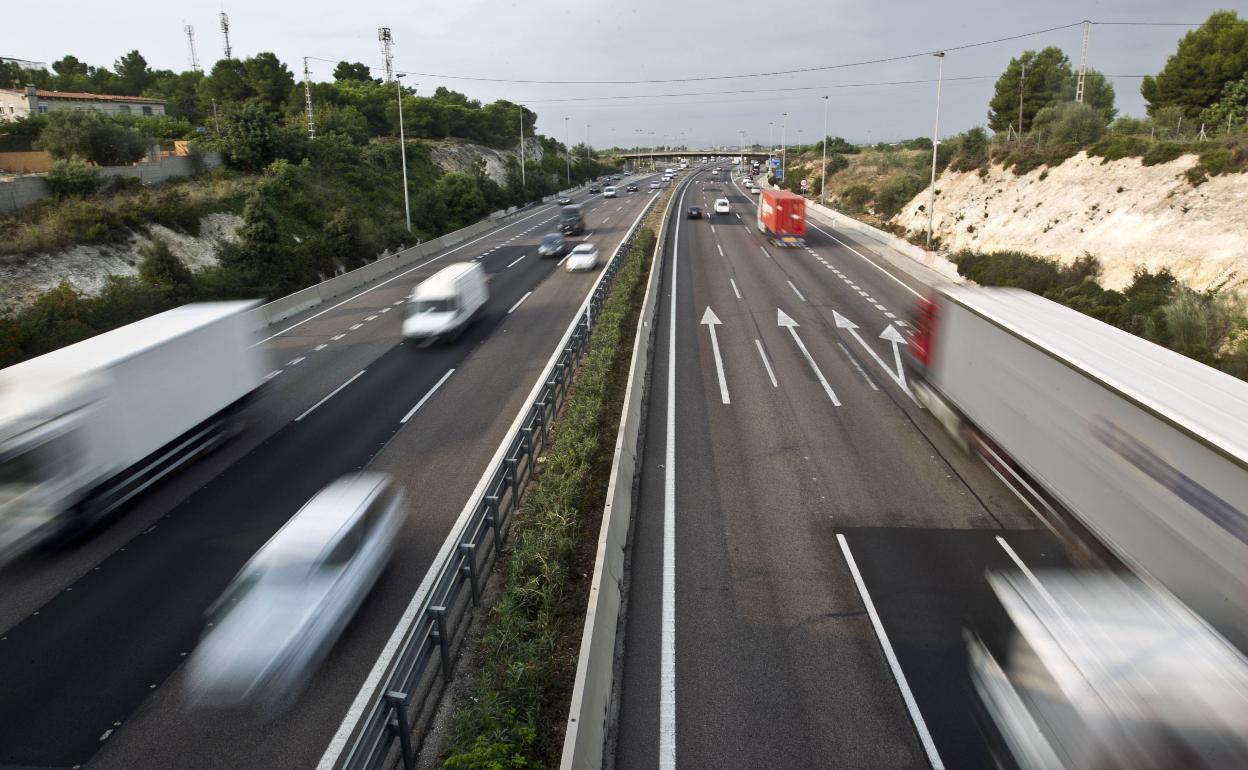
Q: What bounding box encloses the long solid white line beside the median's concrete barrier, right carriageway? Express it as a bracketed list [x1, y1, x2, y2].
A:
[659, 175, 689, 770]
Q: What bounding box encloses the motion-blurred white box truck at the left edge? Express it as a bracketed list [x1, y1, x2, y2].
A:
[0, 302, 267, 562]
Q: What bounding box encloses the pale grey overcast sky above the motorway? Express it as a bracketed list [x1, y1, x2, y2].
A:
[0, 0, 1234, 146]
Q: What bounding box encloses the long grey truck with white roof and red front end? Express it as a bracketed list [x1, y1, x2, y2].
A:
[906, 286, 1248, 649]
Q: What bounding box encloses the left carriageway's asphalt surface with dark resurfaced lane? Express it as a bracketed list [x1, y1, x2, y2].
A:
[0, 177, 649, 768]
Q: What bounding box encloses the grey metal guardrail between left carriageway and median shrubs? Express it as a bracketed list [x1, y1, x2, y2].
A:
[331, 185, 658, 769]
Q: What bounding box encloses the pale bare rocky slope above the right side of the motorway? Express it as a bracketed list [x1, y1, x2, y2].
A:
[892, 152, 1248, 290]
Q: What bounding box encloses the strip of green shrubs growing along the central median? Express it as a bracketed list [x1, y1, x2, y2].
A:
[446, 224, 655, 770]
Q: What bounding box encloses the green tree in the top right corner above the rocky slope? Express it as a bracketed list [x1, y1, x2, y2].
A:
[1139, 11, 1248, 119]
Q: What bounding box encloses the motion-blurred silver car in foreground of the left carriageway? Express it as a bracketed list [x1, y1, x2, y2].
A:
[187, 473, 404, 713]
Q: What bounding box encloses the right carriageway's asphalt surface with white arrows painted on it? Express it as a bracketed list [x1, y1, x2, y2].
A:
[608, 167, 1065, 769]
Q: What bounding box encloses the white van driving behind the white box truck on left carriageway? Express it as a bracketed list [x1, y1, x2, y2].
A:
[403, 262, 489, 339]
